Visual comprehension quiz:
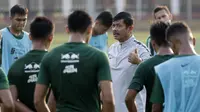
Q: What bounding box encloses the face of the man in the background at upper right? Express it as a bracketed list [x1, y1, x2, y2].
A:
[154, 10, 172, 23]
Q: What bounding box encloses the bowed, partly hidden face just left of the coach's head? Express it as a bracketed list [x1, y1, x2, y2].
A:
[93, 22, 109, 35]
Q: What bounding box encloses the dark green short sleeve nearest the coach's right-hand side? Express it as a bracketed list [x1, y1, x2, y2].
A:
[129, 62, 148, 92]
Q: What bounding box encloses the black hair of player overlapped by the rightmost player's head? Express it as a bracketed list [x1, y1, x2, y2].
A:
[150, 22, 169, 46]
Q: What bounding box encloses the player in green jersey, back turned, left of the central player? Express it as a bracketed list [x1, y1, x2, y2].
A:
[8, 17, 54, 112]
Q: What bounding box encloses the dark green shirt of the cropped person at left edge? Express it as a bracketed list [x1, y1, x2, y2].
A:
[0, 68, 9, 90]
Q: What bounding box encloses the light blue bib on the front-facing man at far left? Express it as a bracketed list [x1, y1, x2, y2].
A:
[0, 27, 32, 75]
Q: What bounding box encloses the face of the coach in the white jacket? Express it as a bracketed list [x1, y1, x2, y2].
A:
[112, 19, 130, 42]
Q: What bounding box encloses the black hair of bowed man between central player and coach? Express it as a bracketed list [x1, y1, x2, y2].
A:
[96, 11, 113, 28]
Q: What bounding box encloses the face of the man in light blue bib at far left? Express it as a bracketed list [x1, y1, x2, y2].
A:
[11, 14, 27, 31]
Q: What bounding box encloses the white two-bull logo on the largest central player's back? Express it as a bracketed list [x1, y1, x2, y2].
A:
[61, 52, 79, 63]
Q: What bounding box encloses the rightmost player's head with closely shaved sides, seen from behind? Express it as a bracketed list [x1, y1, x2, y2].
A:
[166, 22, 196, 54]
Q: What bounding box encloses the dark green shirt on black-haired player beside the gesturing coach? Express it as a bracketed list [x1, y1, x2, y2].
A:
[129, 55, 173, 112]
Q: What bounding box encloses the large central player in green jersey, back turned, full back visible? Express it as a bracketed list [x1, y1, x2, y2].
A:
[34, 10, 114, 112]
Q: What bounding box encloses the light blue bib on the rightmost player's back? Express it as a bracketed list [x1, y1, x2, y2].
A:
[155, 56, 200, 112]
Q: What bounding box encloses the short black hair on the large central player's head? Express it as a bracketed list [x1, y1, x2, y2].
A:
[68, 10, 92, 33]
